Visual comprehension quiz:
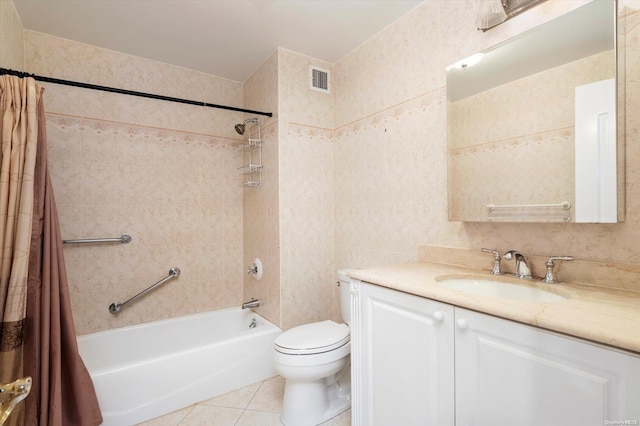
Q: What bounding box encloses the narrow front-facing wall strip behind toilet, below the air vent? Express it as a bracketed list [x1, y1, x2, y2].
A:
[278, 49, 338, 329]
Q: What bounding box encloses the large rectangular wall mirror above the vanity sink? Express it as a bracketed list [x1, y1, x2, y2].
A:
[447, 0, 624, 222]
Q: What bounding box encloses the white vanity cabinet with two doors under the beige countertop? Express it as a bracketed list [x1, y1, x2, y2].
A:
[351, 281, 640, 426]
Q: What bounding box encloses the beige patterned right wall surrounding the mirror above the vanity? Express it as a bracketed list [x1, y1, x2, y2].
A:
[334, 0, 640, 276]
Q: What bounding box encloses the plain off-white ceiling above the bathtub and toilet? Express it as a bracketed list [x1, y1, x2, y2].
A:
[13, 0, 422, 82]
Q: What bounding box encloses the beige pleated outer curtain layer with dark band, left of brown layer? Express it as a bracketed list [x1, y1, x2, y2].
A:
[0, 76, 40, 424]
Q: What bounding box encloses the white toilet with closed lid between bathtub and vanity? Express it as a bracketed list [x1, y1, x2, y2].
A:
[274, 269, 353, 426]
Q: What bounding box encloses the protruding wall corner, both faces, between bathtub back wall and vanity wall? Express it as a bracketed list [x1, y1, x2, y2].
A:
[244, 49, 337, 329]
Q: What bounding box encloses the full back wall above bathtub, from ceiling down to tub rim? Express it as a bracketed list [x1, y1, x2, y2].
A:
[25, 31, 244, 334]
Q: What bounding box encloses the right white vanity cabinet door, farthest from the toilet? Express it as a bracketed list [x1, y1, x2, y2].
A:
[455, 308, 640, 426]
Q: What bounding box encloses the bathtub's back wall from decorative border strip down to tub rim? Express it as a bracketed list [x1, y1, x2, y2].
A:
[47, 112, 242, 334]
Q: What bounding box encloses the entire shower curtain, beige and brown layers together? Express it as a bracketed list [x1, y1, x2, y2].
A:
[0, 75, 102, 426]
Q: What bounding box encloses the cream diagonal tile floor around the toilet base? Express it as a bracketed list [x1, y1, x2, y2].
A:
[140, 377, 351, 426]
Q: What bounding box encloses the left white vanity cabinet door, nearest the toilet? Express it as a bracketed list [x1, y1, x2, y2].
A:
[352, 283, 454, 426]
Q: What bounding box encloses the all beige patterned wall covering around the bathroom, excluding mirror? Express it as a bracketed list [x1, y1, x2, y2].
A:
[5, 0, 640, 333]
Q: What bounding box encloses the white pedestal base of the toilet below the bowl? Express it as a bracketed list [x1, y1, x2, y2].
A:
[280, 365, 351, 426]
